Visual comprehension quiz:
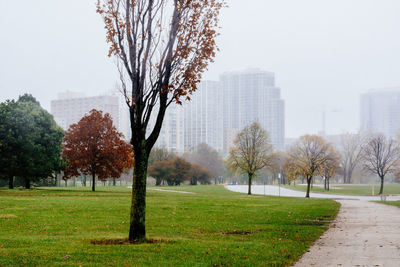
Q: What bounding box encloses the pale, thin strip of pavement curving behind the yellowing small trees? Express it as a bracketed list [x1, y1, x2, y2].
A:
[225, 185, 400, 202]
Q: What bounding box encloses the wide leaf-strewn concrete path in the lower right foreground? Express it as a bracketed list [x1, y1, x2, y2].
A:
[295, 200, 400, 267]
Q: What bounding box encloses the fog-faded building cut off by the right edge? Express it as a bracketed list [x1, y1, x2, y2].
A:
[360, 87, 400, 137]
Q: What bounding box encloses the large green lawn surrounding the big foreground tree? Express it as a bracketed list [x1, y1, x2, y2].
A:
[0, 186, 339, 266]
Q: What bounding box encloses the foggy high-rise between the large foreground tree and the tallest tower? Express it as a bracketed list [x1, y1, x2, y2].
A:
[183, 81, 223, 152]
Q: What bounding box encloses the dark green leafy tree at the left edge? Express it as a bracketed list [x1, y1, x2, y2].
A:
[0, 94, 64, 188]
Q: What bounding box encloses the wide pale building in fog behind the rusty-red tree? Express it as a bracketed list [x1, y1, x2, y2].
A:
[51, 91, 129, 138]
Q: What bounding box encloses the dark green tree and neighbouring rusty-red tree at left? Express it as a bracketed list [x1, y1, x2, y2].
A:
[0, 99, 134, 191]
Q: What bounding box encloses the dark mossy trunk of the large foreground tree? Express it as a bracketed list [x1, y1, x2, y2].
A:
[129, 144, 149, 242]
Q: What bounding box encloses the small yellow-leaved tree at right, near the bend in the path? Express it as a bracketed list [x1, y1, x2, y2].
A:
[286, 135, 333, 197]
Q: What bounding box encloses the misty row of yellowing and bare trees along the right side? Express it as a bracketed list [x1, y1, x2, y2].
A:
[284, 132, 400, 196]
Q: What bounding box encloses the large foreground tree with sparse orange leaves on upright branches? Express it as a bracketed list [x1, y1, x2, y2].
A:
[97, 0, 225, 242]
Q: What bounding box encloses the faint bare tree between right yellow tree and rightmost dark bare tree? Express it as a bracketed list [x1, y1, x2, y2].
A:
[339, 133, 365, 184]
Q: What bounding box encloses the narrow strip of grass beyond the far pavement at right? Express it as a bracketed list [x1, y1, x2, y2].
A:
[285, 184, 400, 196]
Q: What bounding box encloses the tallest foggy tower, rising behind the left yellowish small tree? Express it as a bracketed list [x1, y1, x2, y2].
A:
[220, 69, 285, 152]
